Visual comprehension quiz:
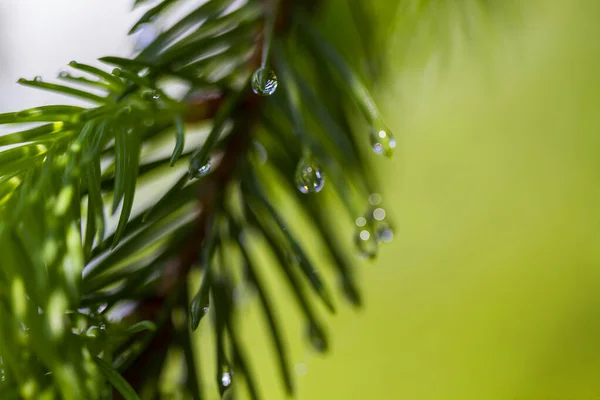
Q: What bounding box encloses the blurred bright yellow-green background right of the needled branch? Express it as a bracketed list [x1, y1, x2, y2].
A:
[203, 1, 600, 400]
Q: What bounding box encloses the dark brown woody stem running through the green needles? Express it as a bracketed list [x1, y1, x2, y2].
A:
[115, 1, 304, 398]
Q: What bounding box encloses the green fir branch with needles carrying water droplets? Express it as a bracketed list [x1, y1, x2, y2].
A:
[0, 0, 404, 399]
